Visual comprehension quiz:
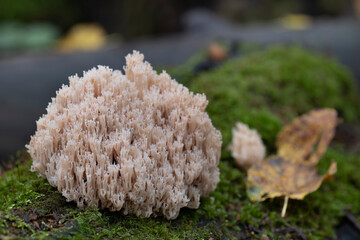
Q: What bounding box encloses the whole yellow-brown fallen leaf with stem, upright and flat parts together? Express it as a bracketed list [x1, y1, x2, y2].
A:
[247, 109, 338, 216]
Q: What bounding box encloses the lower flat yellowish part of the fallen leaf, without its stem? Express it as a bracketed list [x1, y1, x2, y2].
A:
[247, 156, 336, 201]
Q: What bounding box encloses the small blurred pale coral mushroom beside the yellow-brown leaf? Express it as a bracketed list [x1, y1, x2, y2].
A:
[229, 123, 266, 169]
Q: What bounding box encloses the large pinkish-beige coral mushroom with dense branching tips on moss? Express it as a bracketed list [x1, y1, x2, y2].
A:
[27, 51, 221, 219]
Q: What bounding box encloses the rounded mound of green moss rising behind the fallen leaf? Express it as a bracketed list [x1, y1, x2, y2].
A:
[188, 44, 360, 157]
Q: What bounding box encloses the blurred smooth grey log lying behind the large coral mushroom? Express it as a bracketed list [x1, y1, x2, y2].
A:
[0, 10, 360, 160]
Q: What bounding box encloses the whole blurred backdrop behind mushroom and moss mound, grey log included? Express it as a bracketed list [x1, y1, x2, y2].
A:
[0, 0, 360, 162]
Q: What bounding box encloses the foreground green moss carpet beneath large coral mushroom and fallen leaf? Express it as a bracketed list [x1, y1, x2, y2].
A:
[0, 148, 360, 239]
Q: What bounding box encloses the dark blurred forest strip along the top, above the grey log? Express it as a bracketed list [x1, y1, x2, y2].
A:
[0, 0, 358, 40]
